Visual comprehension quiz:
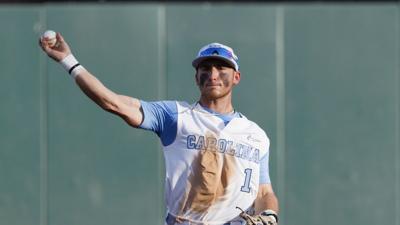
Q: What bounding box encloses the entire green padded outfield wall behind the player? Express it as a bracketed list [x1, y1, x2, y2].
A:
[0, 1, 400, 225]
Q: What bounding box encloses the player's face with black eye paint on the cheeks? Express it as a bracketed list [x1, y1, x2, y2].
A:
[196, 59, 240, 99]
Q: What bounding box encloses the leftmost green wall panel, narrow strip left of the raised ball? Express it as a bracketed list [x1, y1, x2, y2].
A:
[0, 6, 44, 225]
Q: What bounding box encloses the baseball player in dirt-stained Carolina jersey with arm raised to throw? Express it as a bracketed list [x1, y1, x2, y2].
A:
[39, 33, 279, 225]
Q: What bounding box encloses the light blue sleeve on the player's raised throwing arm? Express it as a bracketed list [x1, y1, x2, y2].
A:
[139, 100, 178, 146]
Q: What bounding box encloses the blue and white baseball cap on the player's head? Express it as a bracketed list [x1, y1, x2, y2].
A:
[192, 43, 239, 71]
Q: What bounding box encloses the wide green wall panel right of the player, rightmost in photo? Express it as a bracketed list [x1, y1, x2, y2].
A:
[285, 5, 399, 225]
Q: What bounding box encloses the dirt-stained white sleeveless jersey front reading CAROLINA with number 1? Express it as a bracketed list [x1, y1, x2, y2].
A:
[163, 102, 269, 225]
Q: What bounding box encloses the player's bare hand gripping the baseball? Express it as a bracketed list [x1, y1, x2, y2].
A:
[39, 32, 71, 62]
